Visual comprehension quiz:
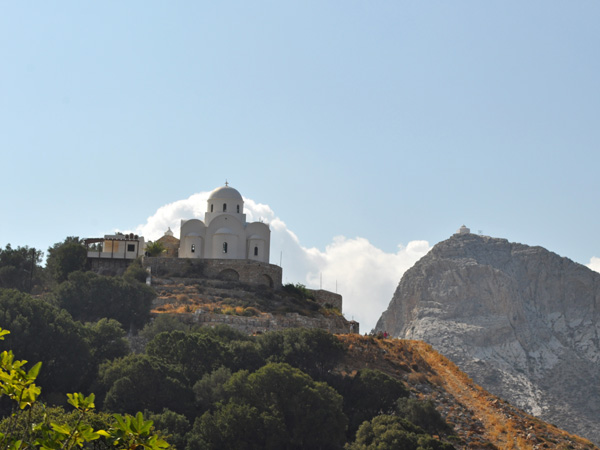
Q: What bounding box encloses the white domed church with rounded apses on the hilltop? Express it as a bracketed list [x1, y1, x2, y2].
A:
[179, 183, 271, 263]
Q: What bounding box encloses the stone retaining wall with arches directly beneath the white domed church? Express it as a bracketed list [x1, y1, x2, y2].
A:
[142, 256, 282, 289]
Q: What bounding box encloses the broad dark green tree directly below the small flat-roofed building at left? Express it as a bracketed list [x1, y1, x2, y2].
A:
[54, 272, 156, 328]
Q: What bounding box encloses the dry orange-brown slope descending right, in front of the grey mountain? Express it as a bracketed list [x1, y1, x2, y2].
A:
[338, 334, 598, 450]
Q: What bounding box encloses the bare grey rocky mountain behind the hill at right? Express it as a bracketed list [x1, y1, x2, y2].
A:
[376, 234, 600, 443]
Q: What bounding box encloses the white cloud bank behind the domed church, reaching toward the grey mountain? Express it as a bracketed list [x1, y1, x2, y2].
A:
[135, 192, 432, 332]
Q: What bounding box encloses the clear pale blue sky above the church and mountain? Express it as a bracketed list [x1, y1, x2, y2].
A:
[0, 0, 600, 330]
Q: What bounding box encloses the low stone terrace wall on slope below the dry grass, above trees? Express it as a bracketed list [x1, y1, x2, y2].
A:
[155, 312, 359, 334]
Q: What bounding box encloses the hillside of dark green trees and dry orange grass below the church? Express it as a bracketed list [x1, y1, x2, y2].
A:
[0, 244, 596, 450]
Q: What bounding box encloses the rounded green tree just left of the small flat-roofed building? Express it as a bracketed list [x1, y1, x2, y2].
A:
[46, 236, 87, 283]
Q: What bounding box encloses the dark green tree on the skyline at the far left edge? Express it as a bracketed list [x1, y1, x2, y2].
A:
[0, 244, 43, 292]
